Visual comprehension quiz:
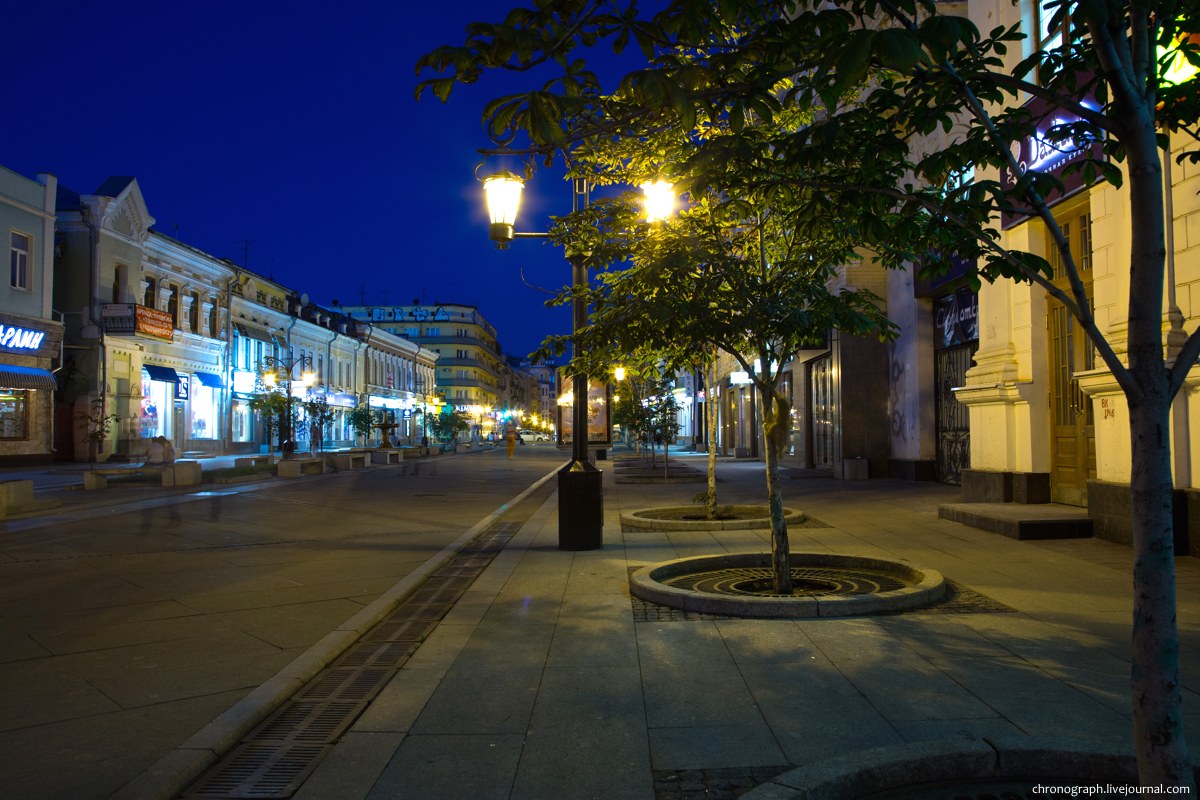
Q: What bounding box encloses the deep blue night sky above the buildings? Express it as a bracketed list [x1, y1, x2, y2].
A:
[0, 0, 619, 355]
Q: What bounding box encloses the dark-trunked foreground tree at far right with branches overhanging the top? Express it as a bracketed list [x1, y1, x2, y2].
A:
[419, 0, 1200, 787]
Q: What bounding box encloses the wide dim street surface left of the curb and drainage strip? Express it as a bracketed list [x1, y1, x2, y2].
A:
[0, 444, 565, 800]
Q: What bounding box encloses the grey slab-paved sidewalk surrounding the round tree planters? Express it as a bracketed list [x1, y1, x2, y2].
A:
[265, 459, 1200, 800]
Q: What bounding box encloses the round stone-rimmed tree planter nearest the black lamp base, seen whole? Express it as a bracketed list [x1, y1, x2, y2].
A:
[629, 553, 946, 618]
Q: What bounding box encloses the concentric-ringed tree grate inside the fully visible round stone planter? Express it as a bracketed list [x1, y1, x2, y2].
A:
[662, 567, 907, 597]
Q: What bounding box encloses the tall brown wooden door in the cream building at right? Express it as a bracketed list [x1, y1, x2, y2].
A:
[1046, 203, 1096, 506]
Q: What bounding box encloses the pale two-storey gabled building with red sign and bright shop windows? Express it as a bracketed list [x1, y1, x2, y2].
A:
[54, 178, 234, 459]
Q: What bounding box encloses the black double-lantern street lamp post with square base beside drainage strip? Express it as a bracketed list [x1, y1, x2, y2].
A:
[484, 164, 673, 551]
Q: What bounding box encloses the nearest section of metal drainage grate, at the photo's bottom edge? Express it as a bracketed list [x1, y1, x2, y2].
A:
[184, 744, 331, 800]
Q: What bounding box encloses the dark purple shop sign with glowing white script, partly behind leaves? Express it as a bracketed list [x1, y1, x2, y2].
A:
[1000, 97, 1104, 229]
